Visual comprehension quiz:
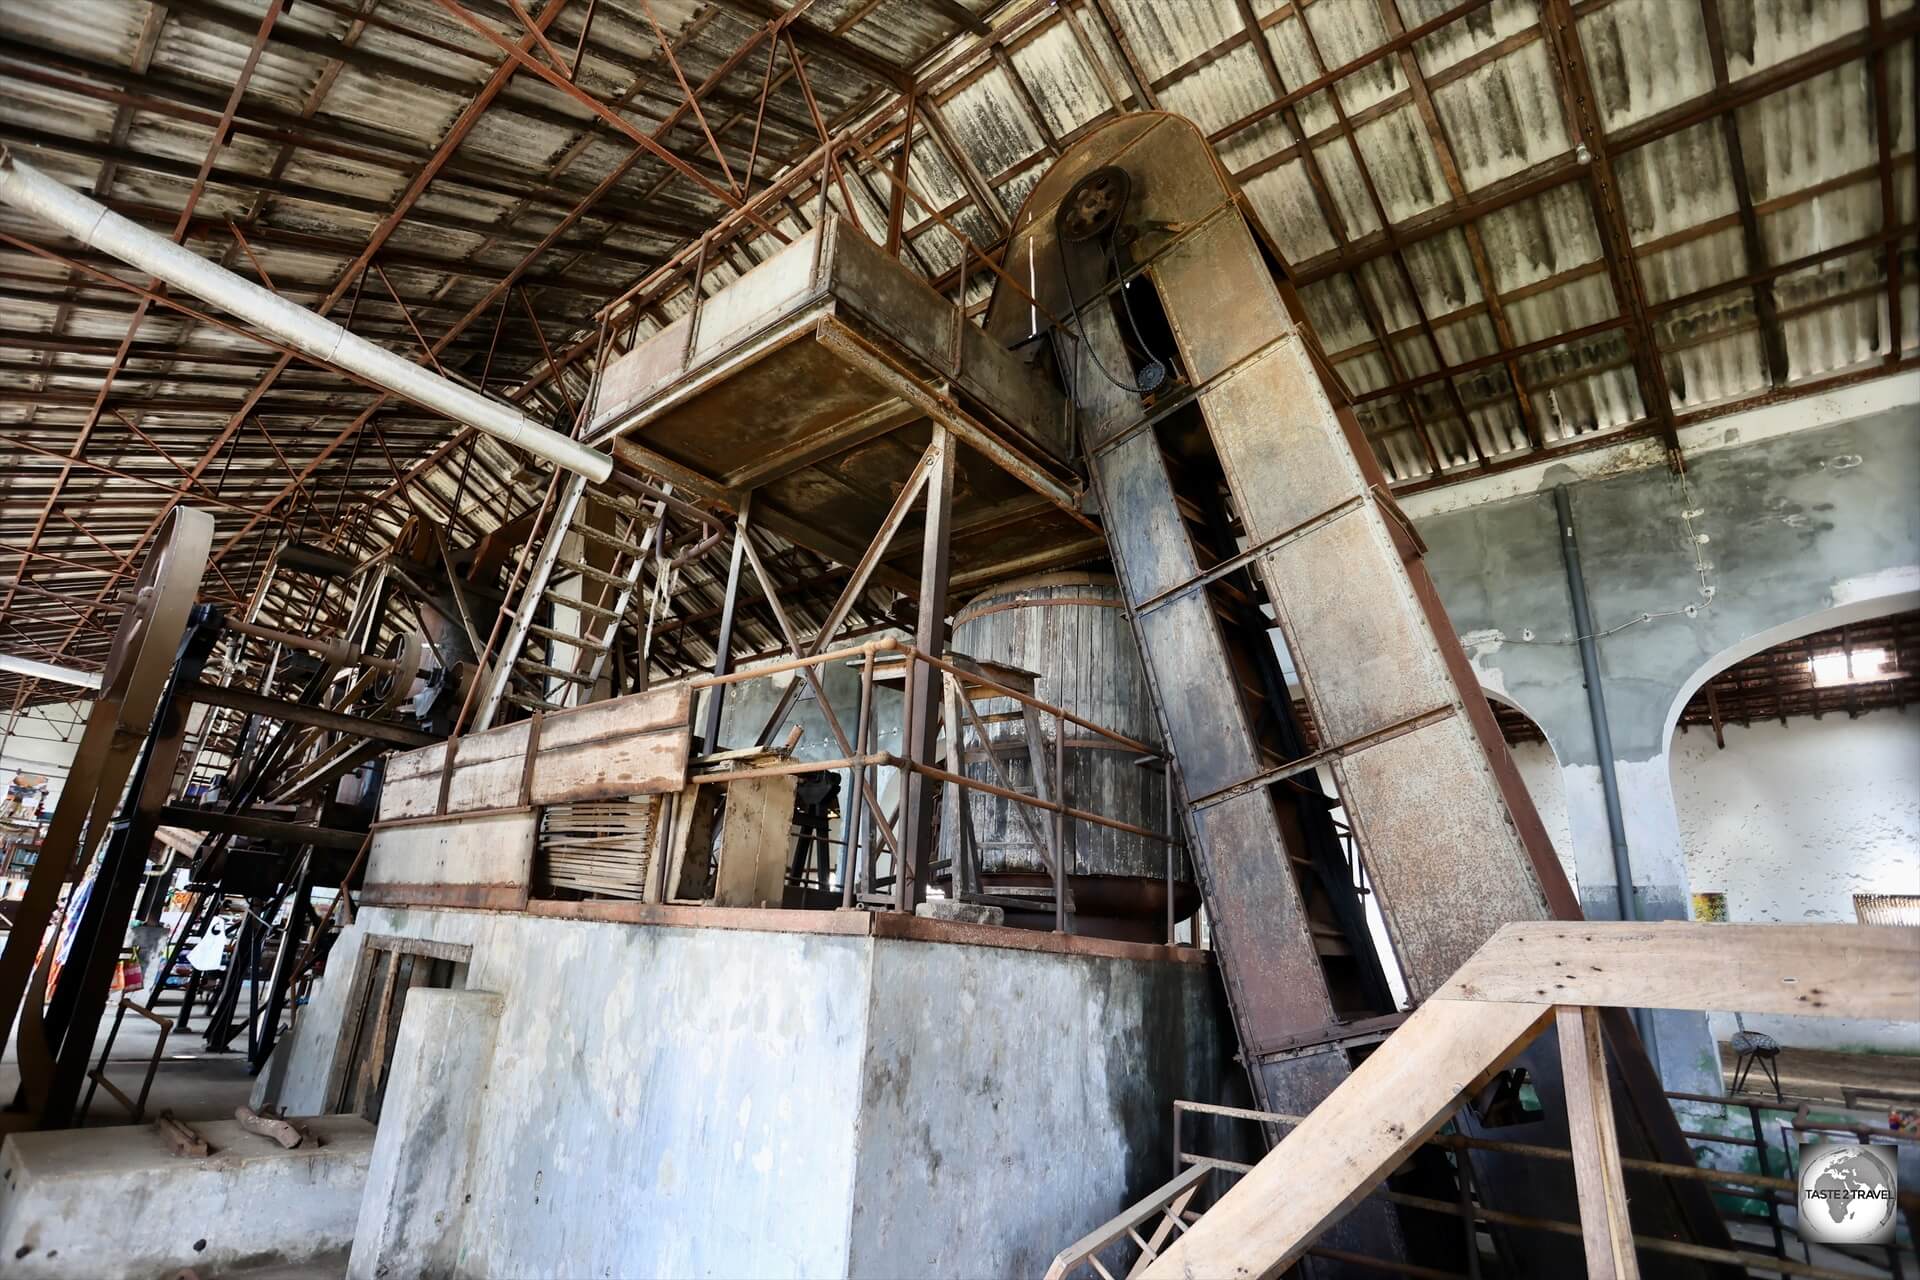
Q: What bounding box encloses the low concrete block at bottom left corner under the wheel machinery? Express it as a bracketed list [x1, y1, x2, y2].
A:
[0, 1115, 374, 1280]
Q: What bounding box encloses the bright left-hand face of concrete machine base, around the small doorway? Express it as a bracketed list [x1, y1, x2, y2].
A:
[282, 908, 870, 1276]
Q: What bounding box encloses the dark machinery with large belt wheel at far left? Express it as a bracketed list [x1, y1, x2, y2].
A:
[0, 509, 456, 1128]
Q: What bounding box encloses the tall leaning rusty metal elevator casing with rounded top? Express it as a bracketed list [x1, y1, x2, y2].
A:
[987, 115, 1724, 1274]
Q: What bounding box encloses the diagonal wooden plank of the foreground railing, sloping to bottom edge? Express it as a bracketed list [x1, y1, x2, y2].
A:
[1144, 1000, 1551, 1280]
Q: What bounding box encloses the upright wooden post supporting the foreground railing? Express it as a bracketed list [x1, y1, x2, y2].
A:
[1553, 1004, 1640, 1280]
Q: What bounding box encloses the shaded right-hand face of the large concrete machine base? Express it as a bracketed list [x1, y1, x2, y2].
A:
[847, 940, 1233, 1280]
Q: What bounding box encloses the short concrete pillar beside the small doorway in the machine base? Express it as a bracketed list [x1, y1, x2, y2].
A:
[348, 990, 505, 1280]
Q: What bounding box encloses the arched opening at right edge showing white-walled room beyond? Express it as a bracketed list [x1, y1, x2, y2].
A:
[1668, 595, 1920, 1092]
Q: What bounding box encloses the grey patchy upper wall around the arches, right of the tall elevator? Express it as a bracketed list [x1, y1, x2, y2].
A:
[1407, 376, 1920, 1088]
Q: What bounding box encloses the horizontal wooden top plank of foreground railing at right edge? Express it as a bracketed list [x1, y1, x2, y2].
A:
[1434, 921, 1920, 1021]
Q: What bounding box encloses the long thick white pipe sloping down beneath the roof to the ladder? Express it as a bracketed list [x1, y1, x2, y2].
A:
[0, 146, 612, 482]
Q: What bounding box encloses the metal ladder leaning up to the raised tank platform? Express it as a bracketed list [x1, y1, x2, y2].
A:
[470, 476, 672, 733]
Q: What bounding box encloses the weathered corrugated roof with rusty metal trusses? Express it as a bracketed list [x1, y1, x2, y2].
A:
[0, 0, 1896, 697]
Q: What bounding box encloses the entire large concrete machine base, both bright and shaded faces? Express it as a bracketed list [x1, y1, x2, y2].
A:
[263, 908, 1235, 1276]
